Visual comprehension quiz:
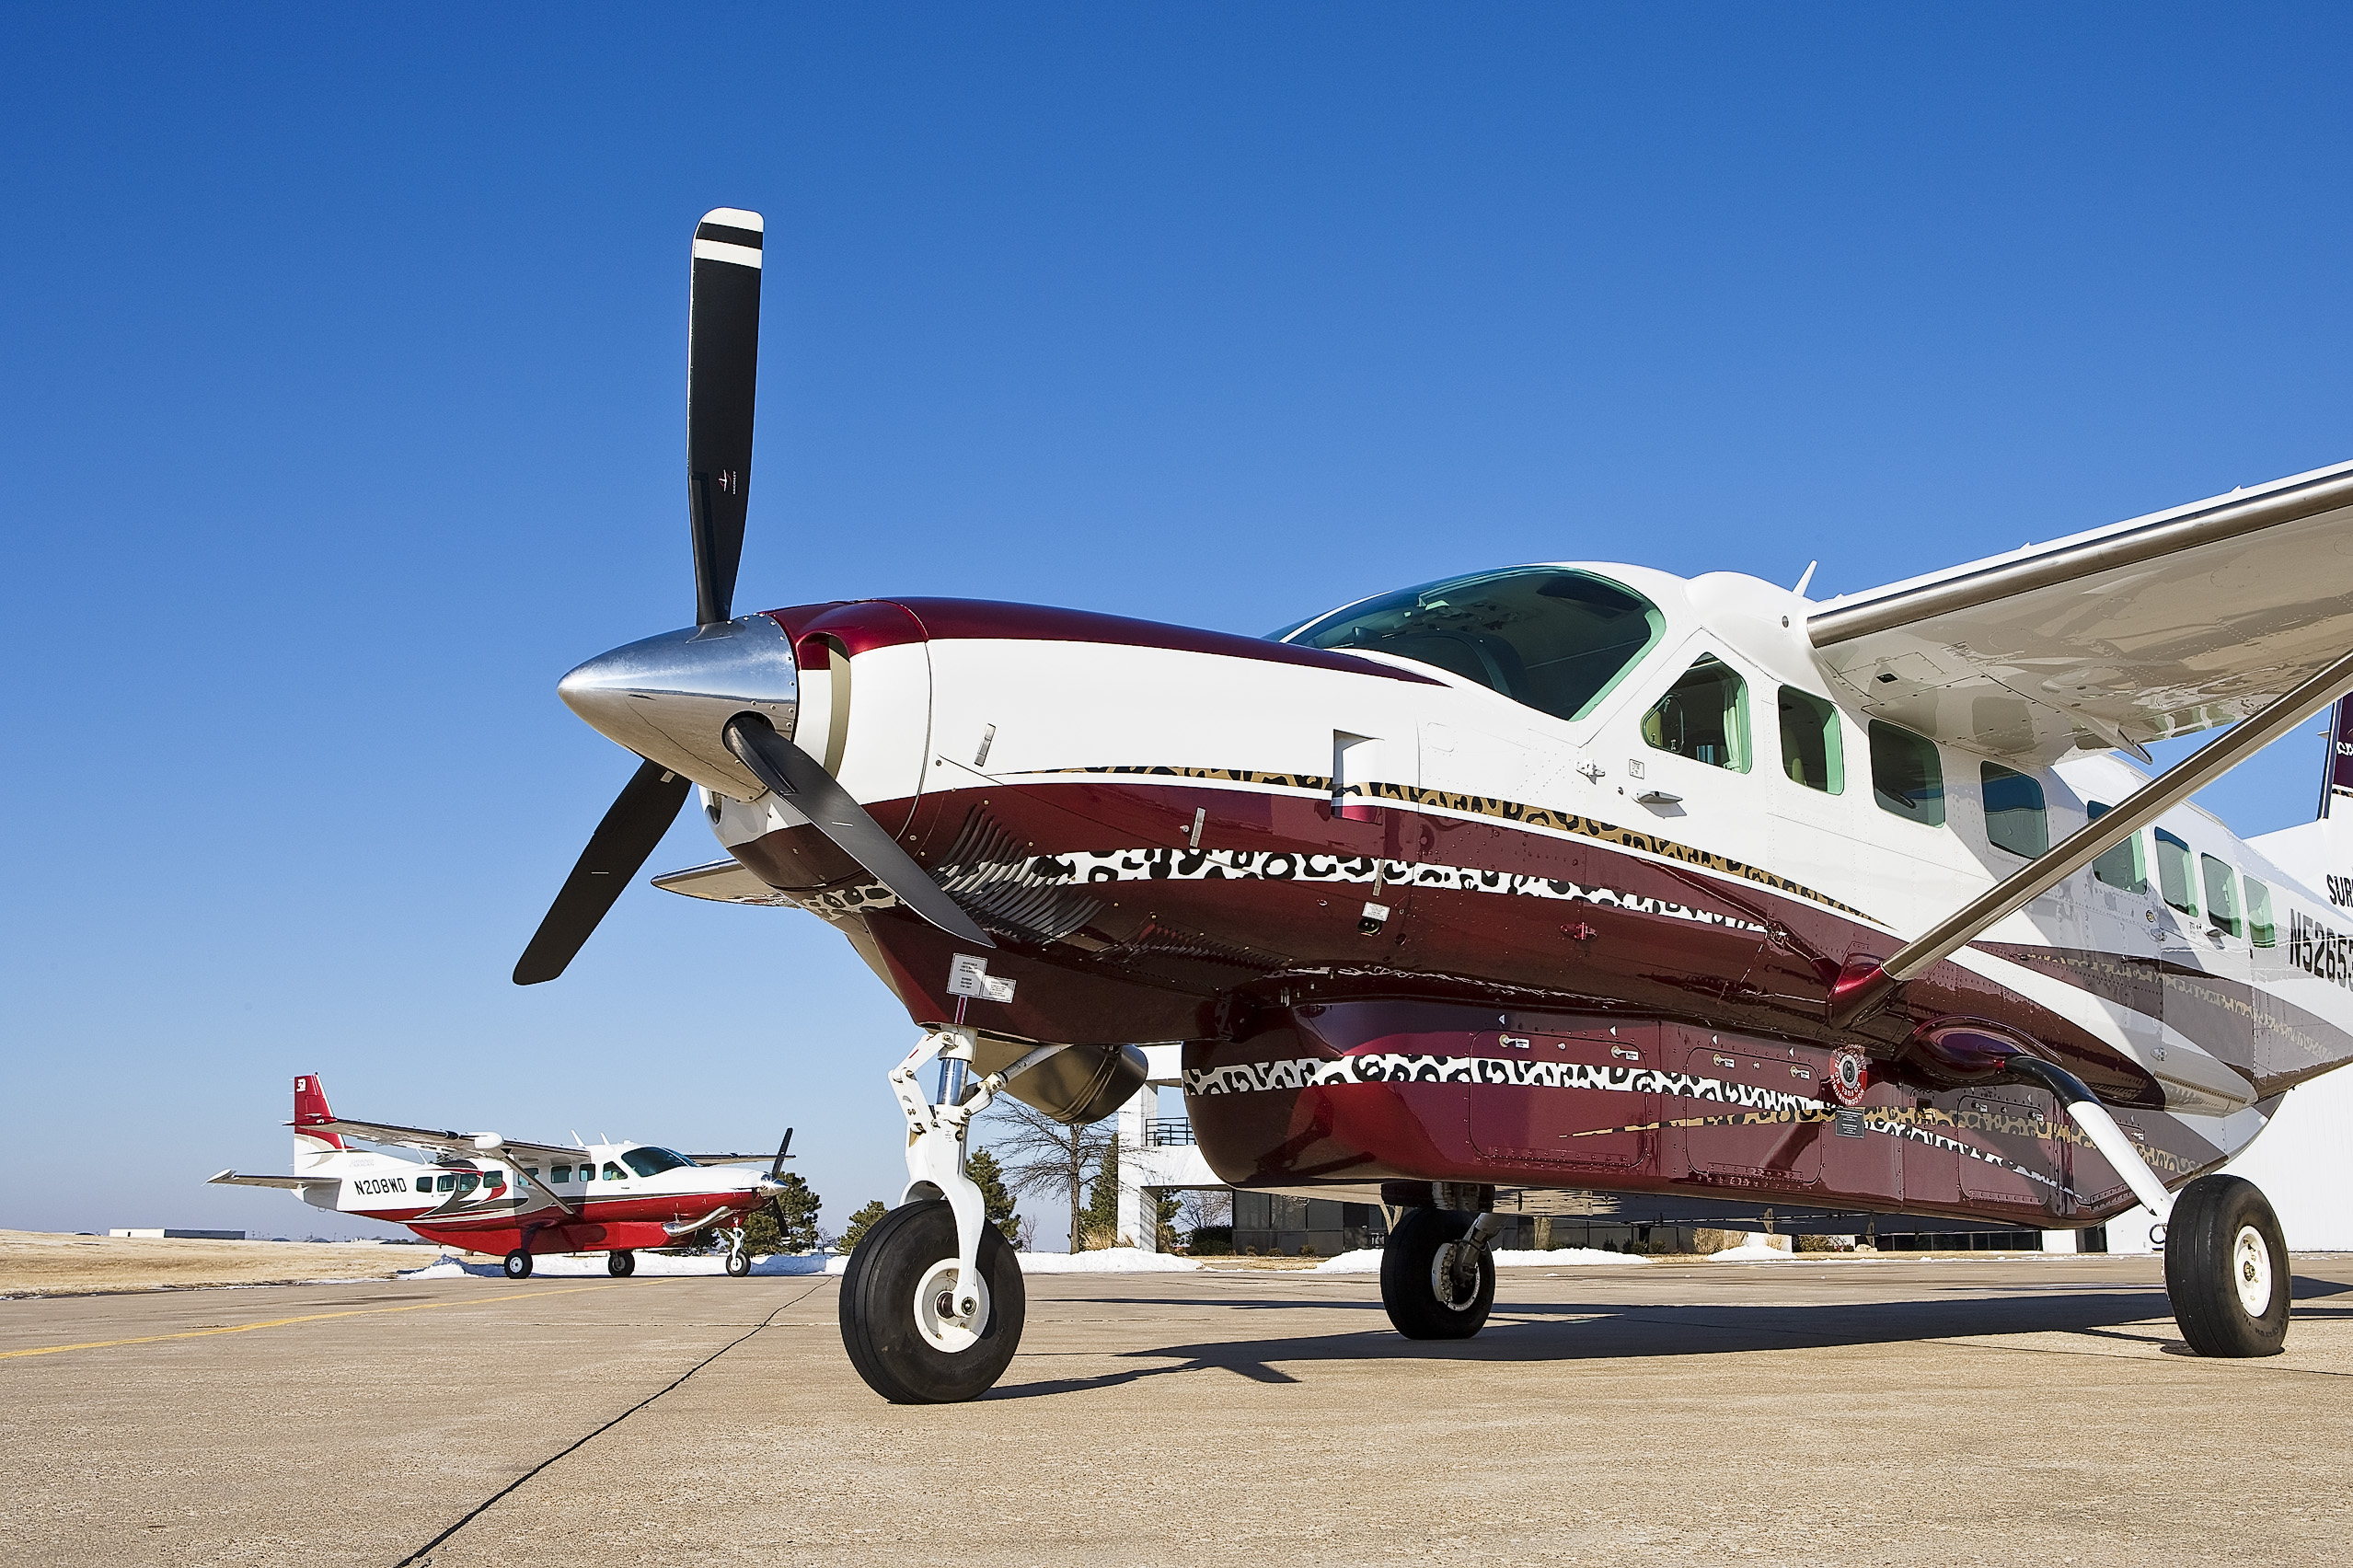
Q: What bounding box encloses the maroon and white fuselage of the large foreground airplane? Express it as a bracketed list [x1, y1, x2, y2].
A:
[673, 565, 2353, 1224]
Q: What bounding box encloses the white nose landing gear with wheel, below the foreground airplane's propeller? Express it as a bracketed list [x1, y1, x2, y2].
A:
[840, 1027, 1061, 1405]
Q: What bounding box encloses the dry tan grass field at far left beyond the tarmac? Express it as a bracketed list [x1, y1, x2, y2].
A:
[0, 1231, 423, 1297]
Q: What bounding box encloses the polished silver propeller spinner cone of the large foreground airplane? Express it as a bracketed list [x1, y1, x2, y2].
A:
[555, 615, 800, 801]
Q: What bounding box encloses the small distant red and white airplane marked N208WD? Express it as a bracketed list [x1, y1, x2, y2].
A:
[210, 1074, 793, 1278]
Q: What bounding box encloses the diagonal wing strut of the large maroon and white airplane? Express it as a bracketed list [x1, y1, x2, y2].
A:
[1830, 635, 2353, 1029]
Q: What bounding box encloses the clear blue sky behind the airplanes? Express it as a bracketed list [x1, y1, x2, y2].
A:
[0, 5, 2353, 1234]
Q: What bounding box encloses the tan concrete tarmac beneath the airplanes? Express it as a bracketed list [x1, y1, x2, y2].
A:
[0, 1255, 2353, 1568]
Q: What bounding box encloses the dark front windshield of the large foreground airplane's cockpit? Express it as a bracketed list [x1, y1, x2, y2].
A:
[1280, 568, 1666, 718]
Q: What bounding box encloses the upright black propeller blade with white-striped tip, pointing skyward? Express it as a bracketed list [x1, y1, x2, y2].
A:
[687, 207, 762, 627]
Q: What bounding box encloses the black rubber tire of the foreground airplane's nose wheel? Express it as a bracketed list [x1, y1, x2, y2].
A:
[840, 1198, 1028, 1405]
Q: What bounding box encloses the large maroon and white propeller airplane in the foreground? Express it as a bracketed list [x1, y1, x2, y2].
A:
[515, 210, 2353, 1401]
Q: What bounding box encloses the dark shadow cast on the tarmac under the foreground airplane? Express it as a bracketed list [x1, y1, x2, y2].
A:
[984, 1278, 2353, 1399]
